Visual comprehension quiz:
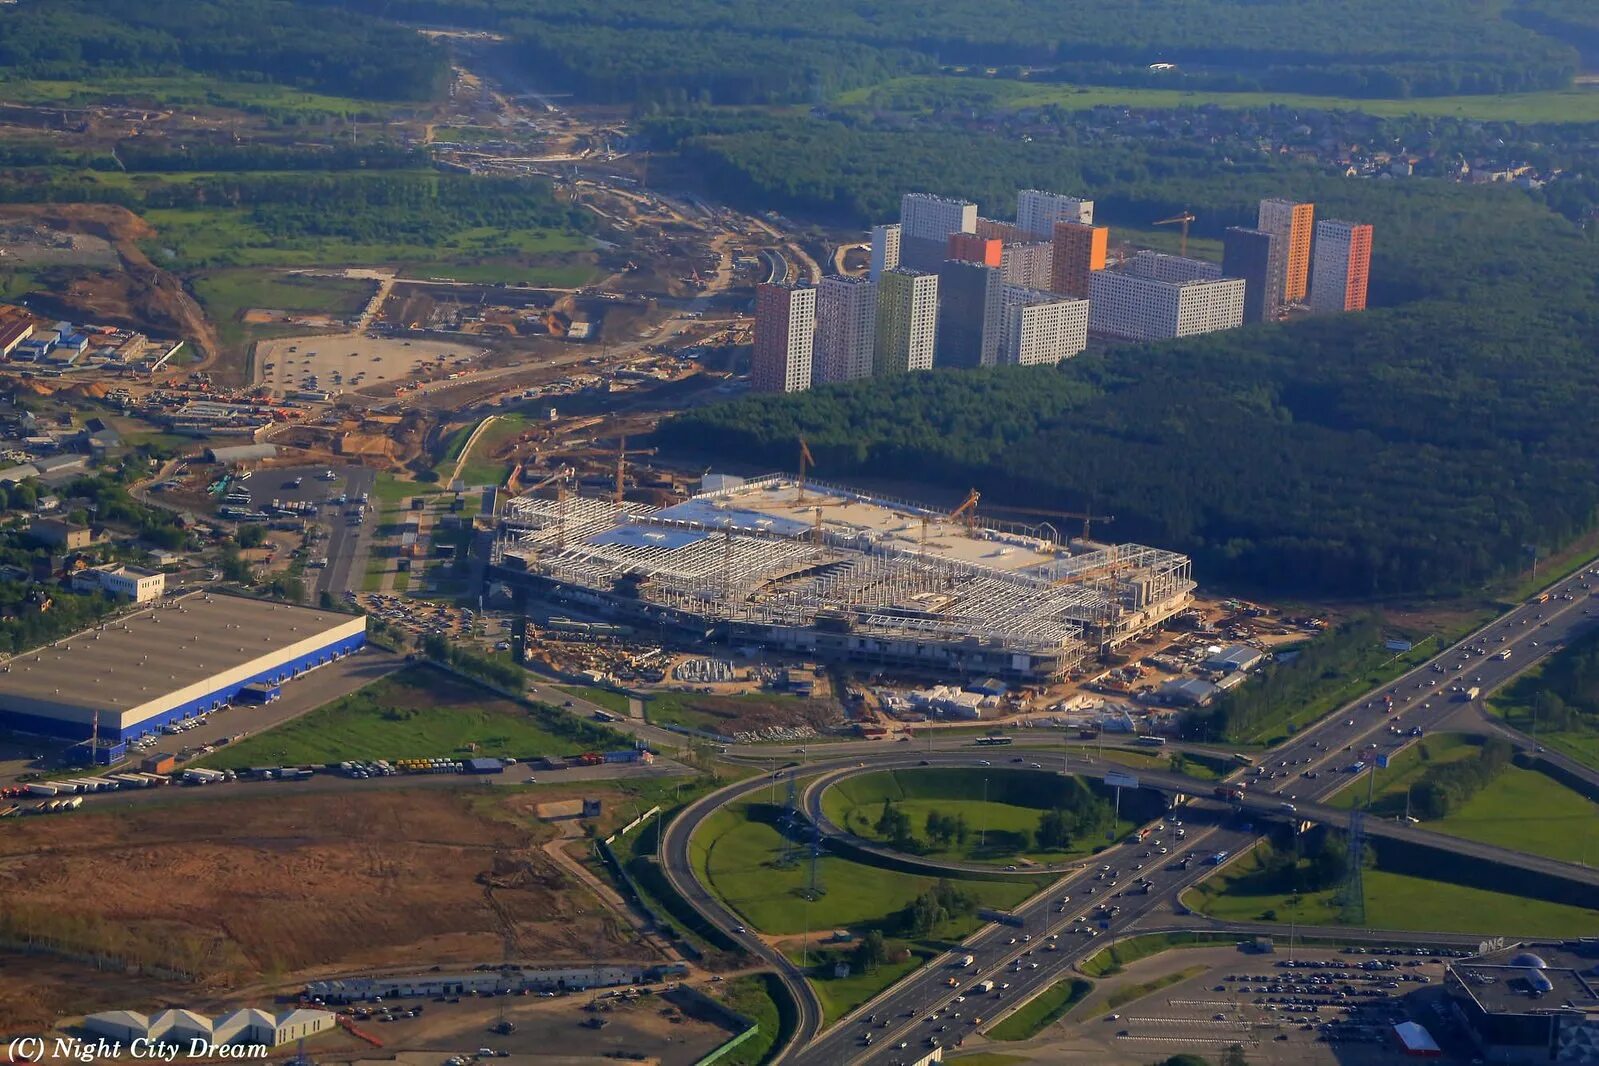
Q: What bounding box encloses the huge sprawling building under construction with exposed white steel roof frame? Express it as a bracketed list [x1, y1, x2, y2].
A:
[492, 476, 1194, 682]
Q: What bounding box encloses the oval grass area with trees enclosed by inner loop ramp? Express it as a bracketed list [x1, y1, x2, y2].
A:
[822, 766, 1137, 863]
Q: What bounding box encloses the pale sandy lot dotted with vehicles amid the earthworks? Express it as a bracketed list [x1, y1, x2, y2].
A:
[256, 334, 483, 396]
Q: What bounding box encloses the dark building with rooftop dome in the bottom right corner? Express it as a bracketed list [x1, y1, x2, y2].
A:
[1444, 940, 1599, 1064]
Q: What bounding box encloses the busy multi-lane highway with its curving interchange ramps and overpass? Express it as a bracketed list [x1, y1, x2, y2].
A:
[662, 571, 1599, 1063]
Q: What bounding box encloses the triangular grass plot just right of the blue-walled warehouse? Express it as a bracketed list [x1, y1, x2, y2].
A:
[195, 668, 610, 769]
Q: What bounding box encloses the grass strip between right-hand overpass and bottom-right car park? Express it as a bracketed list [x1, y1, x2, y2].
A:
[1183, 858, 1599, 938]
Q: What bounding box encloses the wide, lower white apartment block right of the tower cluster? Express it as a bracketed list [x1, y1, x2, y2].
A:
[1089, 270, 1244, 340]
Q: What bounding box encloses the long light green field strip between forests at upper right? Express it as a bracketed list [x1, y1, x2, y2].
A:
[833, 77, 1599, 123]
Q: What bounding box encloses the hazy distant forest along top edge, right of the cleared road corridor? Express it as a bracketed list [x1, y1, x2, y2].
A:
[305, 0, 1577, 104]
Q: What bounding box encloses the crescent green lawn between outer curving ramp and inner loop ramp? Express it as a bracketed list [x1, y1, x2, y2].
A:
[691, 796, 1051, 938]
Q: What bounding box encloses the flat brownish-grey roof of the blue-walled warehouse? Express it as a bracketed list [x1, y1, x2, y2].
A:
[0, 593, 364, 711]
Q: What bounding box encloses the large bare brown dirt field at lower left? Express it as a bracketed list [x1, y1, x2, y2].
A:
[0, 790, 654, 1032]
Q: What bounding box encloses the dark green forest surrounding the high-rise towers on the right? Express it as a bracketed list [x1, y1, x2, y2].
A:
[660, 123, 1599, 596]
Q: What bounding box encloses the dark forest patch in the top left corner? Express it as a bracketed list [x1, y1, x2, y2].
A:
[0, 0, 449, 101]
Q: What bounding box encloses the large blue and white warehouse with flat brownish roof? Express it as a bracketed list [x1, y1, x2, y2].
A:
[0, 593, 366, 761]
